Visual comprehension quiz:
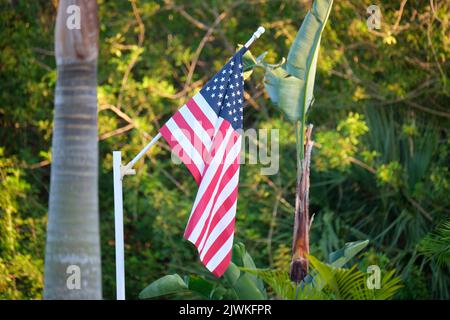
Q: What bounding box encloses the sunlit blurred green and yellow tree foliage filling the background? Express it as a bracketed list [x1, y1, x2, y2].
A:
[0, 0, 450, 299]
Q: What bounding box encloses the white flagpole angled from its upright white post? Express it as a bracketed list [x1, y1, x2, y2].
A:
[113, 27, 265, 300]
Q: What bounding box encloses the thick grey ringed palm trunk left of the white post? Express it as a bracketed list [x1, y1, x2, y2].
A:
[44, 0, 102, 299]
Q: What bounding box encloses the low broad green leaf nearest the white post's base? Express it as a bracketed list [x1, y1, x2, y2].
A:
[139, 274, 189, 299]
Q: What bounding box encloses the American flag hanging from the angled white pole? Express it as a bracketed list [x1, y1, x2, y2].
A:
[160, 47, 247, 277]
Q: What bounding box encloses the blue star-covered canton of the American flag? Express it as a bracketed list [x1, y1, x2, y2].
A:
[200, 47, 247, 130]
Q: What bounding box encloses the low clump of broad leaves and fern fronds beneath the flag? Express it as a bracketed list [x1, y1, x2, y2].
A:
[139, 240, 398, 300]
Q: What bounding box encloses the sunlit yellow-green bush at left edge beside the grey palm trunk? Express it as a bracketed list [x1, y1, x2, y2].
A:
[0, 148, 46, 299]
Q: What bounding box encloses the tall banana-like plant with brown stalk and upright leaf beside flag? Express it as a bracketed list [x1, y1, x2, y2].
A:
[244, 0, 333, 283]
